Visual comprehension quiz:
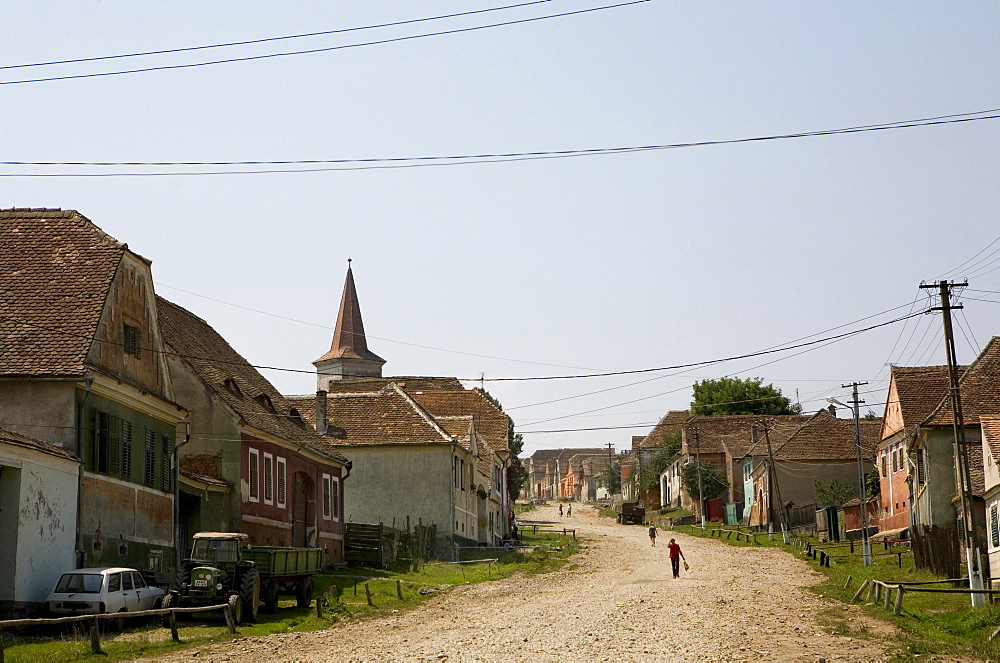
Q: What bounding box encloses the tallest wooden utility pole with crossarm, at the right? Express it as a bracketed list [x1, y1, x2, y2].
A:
[920, 281, 985, 606]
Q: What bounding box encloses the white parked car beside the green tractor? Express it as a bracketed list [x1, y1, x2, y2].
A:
[46, 567, 166, 615]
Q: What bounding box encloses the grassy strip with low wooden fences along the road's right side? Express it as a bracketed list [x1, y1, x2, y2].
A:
[675, 523, 1000, 661]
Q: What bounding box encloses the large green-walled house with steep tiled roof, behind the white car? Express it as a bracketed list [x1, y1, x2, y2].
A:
[0, 209, 188, 583]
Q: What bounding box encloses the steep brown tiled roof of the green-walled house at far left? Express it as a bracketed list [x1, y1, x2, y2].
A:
[0, 209, 128, 376]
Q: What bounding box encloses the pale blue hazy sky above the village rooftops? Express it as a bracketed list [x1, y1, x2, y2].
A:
[0, 0, 1000, 455]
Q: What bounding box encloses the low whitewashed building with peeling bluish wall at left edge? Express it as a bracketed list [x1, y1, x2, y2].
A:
[0, 429, 80, 619]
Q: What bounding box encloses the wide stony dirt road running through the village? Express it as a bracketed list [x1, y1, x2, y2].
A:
[154, 505, 885, 661]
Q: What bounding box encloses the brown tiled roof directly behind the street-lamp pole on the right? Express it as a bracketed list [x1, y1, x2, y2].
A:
[772, 410, 882, 460]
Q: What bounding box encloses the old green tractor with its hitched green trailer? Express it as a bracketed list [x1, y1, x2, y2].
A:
[163, 532, 325, 624]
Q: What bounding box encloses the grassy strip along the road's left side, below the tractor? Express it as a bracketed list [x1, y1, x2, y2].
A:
[3, 532, 578, 663]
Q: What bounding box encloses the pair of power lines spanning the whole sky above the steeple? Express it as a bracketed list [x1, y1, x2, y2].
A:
[0, 113, 1000, 177]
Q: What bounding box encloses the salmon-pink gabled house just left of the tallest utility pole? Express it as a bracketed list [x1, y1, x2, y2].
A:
[876, 366, 948, 536]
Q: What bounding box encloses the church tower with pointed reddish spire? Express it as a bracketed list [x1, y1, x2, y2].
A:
[313, 259, 385, 391]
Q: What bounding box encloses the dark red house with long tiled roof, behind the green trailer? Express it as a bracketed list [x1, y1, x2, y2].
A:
[157, 298, 350, 564]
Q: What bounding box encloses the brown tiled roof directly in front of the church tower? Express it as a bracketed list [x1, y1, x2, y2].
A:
[288, 383, 452, 446]
